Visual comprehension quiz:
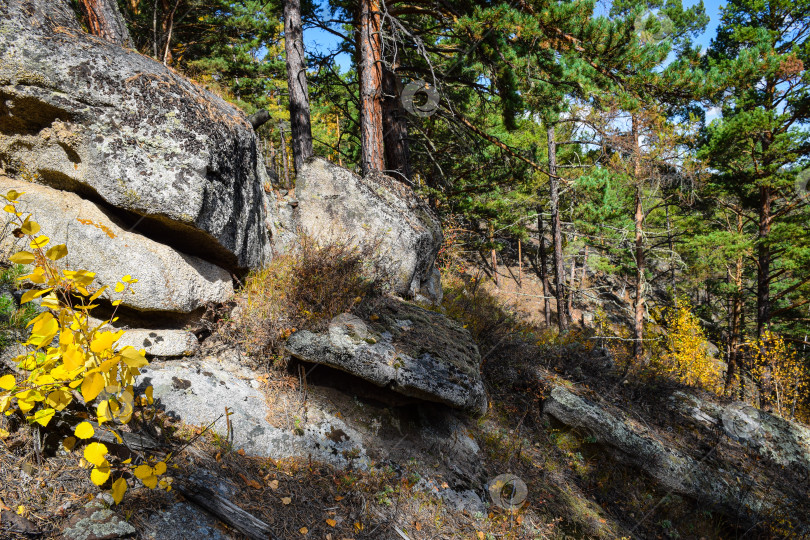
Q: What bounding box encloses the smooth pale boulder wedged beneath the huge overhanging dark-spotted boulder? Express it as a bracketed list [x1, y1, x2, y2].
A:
[0, 176, 233, 313]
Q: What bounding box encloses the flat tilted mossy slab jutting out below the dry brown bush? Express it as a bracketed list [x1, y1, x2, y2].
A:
[286, 298, 487, 415]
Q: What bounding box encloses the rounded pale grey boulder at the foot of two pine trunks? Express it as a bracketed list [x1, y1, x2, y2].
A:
[295, 158, 442, 301]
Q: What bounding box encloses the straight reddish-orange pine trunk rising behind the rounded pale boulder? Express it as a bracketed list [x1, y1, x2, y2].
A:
[357, 0, 385, 175]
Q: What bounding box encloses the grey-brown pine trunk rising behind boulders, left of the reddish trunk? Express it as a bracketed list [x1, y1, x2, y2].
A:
[284, 0, 312, 174]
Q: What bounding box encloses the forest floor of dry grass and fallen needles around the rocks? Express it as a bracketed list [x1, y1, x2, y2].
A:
[0, 260, 804, 540]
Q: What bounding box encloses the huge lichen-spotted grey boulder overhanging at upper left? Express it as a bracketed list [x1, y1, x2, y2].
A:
[0, 0, 269, 271]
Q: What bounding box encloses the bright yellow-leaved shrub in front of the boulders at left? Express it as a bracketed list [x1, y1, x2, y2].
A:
[0, 190, 169, 503]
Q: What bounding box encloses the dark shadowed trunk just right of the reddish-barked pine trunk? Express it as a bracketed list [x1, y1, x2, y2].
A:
[382, 68, 412, 181]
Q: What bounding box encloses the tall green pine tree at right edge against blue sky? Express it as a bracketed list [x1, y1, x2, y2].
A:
[703, 0, 810, 337]
